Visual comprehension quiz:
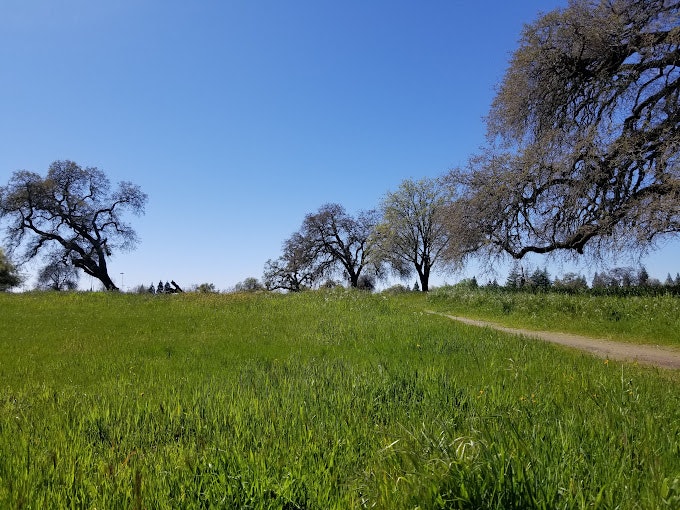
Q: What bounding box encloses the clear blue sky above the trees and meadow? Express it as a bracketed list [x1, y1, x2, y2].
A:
[0, 0, 680, 289]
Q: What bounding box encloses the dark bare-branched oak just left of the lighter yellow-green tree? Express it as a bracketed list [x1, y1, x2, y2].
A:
[299, 204, 379, 287]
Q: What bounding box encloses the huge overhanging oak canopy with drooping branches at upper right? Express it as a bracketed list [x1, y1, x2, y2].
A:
[448, 0, 680, 258]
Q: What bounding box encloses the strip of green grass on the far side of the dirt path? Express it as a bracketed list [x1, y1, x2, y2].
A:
[427, 286, 680, 347]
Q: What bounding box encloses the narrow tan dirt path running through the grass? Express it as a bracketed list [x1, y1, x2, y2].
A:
[427, 310, 680, 369]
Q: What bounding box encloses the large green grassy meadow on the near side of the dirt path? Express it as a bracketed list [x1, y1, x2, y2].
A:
[0, 289, 680, 509]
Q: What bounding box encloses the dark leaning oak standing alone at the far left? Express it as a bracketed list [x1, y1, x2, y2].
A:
[0, 161, 147, 290]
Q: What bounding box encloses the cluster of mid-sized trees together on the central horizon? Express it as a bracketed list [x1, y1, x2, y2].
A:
[263, 178, 452, 292]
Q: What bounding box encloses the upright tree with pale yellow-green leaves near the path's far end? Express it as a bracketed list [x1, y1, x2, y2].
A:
[375, 178, 450, 292]
